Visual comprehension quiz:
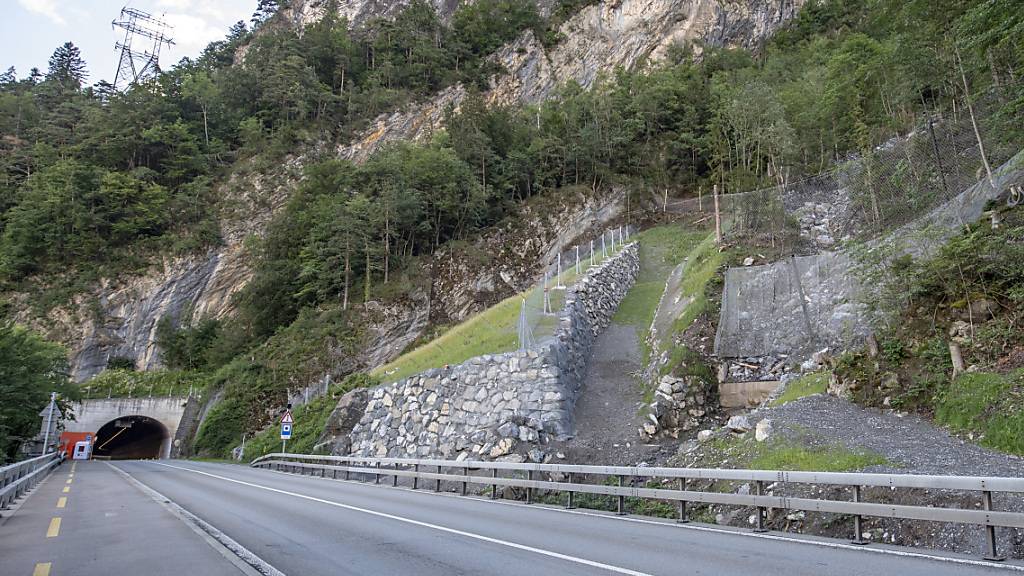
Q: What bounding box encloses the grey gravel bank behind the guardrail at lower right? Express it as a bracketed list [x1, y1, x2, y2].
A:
[750, 395, 1024, 477]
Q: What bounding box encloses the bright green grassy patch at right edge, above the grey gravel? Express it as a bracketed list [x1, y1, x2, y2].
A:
[935, 369, 1024, 455]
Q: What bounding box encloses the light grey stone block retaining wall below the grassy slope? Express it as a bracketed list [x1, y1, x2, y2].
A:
[349, 243, 640, 459]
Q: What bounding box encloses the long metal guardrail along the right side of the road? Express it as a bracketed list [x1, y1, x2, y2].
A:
[250, 453, 1024, 561]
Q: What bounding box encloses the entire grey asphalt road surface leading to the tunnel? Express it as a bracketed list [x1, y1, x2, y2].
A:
[0, 461, 1022, 576]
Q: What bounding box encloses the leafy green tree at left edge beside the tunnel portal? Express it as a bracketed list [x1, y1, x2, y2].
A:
[0, 323, 78, 464]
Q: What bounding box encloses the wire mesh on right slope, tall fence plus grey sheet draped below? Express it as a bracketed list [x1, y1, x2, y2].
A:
[688, 89, 1024, 358]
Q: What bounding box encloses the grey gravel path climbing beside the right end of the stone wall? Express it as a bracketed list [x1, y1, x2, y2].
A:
[552, 324, 660, 465]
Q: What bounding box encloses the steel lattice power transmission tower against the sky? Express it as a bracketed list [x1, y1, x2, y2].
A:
[111, 7, 174, 90]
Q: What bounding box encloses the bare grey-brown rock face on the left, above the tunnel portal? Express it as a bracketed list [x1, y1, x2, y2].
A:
[25, 158, 302, 381]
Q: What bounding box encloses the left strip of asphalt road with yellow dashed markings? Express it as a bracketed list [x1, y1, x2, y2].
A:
[0, 461, 242, 576]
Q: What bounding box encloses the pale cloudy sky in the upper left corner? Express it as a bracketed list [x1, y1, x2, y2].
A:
[0, 0, 258, 84]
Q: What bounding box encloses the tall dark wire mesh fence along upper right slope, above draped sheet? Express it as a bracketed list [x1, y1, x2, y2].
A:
[665, 92, 1019, 255]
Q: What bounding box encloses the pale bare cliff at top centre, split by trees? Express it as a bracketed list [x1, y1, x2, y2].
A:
[338, 0, 806, 161]
